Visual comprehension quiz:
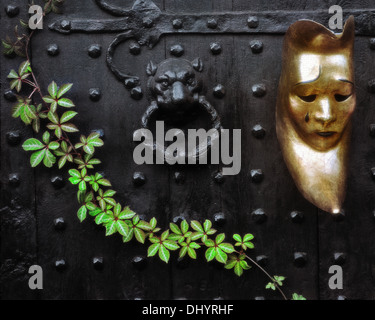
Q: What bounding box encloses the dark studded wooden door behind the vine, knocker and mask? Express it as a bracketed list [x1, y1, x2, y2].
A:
[0, 0, 375, 299]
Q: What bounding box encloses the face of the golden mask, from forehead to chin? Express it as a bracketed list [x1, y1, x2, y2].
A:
[286, 51, 355, 151]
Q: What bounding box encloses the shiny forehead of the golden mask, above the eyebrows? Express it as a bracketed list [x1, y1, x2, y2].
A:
[289, 53, 353, 85]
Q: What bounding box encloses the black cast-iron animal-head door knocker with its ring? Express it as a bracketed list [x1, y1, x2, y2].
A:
[142, 58, 221, 163]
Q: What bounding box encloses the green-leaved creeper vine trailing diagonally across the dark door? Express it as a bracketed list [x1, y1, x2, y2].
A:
[2, 0, 306, 300]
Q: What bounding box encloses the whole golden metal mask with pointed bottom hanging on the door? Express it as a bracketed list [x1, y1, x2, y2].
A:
[276, 16, 356, 213]
